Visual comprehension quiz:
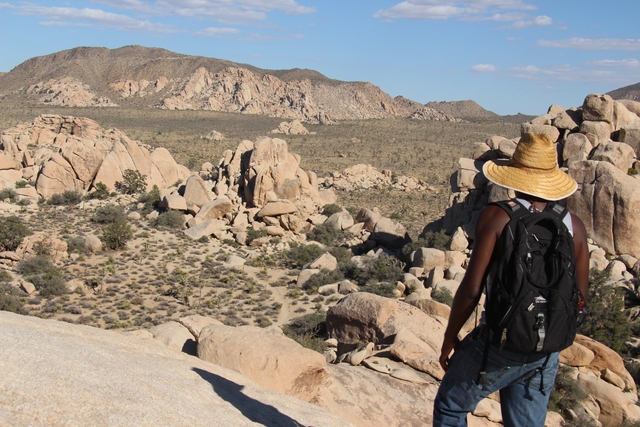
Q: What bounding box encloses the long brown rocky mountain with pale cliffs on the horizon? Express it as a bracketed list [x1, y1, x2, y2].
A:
[0, 46, 490, 123]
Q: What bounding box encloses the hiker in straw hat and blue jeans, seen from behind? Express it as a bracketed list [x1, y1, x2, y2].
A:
[433, 133, 589, 427]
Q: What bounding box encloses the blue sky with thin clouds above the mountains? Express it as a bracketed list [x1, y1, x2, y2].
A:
[0, 0, 640, 115]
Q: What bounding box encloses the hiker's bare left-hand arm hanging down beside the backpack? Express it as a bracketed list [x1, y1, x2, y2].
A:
[440, 205, 509, 371]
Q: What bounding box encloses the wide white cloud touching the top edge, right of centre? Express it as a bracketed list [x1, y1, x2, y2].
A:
[374, 0, 537, 21]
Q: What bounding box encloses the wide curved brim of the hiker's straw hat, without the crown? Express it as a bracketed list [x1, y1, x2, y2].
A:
[482, 159, 578, 201]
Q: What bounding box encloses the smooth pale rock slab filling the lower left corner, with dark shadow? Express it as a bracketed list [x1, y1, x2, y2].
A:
[0, 311, 356, 427]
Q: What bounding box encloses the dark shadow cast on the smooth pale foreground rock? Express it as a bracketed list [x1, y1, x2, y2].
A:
[192, 368, 305, 427]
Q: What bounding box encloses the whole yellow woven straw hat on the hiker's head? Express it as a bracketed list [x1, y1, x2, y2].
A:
[482, 133, 578, 200]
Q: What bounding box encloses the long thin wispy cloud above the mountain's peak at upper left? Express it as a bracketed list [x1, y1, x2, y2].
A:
[18, 5, 177, 33]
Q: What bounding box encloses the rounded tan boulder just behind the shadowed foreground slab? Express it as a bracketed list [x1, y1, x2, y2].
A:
[198, 325, 330, 401]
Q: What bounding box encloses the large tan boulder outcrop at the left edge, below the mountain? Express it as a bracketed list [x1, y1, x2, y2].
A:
[0, 114, 189, 198]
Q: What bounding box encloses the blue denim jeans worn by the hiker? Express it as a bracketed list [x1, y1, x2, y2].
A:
[433, 325, 559, 427]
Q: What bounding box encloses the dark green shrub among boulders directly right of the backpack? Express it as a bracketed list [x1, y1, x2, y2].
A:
[578, 268, 631, 355]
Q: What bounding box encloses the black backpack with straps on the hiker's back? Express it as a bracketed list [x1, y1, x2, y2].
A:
[485, 200, 579, 355]
